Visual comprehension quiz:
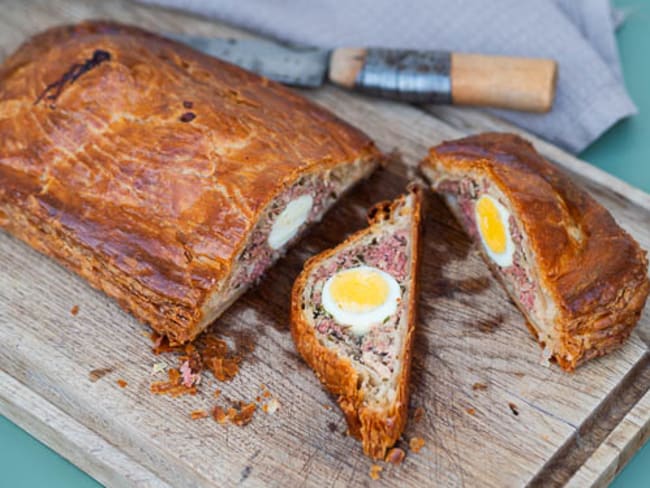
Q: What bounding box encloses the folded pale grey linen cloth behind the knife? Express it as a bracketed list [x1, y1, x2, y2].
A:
[141, 0, 636, 152]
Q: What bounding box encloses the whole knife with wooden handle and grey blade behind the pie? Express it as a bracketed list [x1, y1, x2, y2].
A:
[166, 34, 557, 112]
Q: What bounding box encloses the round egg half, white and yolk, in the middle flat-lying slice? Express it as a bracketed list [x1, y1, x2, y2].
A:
[322, 266, 401, 335]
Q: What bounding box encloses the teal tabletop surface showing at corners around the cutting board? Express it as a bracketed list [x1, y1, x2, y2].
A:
[0, 0, 650, 488]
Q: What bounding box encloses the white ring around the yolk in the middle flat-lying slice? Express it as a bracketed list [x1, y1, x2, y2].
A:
[322, 266, 401, 336]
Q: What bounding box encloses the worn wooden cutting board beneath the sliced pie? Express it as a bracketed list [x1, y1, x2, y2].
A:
[0, 0, 650, 487]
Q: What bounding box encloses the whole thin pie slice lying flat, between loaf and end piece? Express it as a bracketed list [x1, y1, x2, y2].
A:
[291, 186, 422, 458]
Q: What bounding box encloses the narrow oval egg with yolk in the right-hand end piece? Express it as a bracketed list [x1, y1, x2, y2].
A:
[474, 195, 515, 268]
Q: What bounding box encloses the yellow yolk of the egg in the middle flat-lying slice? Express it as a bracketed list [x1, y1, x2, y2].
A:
[330, 270, 389, 313]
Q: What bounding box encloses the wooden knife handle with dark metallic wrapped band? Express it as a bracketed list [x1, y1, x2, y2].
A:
[329, 48, 557, 112]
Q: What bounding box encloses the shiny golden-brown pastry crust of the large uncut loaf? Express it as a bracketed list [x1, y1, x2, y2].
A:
[0, 22, 380, 342]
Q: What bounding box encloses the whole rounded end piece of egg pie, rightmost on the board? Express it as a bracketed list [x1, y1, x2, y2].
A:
[421, 133, 649, 371]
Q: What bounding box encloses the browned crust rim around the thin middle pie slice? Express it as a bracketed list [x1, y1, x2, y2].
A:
[291, 185, 422, 459]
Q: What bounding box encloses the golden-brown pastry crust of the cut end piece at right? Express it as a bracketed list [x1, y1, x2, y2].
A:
[421, 133, 650, 371]
